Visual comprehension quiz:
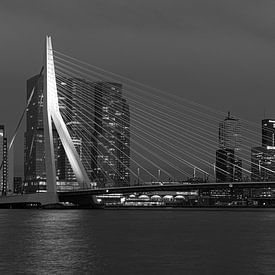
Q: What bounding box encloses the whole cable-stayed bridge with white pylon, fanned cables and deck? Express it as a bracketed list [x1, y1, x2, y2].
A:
[0, 37, 275, 208]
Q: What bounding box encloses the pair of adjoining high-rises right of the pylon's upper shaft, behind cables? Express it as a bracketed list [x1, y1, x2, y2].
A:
[58, 78, 130, 186]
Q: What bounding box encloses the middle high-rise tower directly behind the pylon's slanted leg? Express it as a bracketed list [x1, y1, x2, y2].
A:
[57, 78, 94, 183]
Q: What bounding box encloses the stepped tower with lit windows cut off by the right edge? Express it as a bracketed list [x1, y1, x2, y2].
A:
[251, 119, 275, 181]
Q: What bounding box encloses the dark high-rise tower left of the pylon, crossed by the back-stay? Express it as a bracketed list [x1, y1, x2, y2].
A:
[24, 75, 58, 192]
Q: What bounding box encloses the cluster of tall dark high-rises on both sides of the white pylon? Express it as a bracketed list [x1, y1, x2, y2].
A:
[24, 75, 130, 192]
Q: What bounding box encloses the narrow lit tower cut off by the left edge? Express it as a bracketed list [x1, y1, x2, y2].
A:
[0, 125, 8, 195]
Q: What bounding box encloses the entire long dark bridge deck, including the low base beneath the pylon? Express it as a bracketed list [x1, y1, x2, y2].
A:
[0, 181, 275, 208]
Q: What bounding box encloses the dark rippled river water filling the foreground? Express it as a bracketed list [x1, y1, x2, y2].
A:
[0, 209, 275, 275]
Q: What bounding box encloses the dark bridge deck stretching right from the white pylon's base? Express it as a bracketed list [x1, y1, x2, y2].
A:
[58, 181, 275, 202]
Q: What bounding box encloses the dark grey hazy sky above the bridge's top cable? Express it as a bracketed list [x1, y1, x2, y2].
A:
[0, 0, 275, 176]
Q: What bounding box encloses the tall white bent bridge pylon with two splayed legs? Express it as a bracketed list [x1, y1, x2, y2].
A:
[43, 36, 90, 194]
